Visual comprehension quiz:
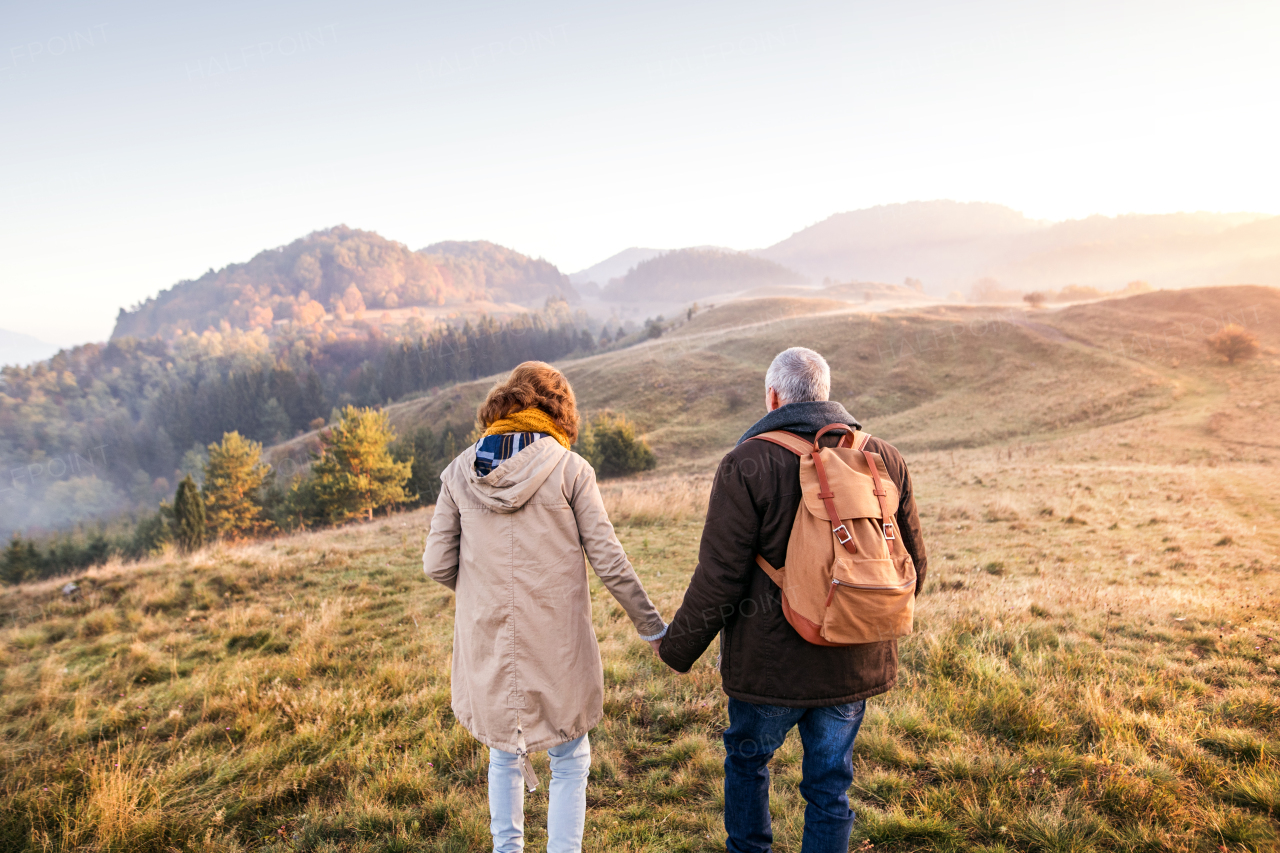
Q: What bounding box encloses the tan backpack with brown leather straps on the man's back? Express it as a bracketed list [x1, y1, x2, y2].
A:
[753, 424, 915, 646]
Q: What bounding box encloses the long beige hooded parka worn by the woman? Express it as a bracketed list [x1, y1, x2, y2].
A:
[422, 438, 666, 752]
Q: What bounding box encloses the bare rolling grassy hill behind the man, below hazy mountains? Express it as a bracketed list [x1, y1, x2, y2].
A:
[275, 281, 1280, 471]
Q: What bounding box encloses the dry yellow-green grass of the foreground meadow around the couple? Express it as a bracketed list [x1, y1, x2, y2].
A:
[3, 423, 1280, 850]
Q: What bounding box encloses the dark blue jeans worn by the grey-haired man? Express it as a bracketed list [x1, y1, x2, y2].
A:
[724, 697, 867, 853]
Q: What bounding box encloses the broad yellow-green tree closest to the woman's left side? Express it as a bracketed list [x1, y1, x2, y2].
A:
[311, 406, 412, 524]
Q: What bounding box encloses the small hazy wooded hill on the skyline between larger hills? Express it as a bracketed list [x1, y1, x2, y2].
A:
[603, 248, 804, 301]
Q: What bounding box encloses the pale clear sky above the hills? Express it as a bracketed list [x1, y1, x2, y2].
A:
[0, 0, 1280, 345]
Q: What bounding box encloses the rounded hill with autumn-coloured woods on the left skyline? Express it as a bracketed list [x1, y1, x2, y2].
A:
[111, 225, 573, 339]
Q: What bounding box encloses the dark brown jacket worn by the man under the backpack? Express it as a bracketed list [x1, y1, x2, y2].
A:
[660, 409, 928, 707]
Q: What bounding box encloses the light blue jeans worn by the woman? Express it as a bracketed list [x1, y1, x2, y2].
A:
[489, 735, 591, 853]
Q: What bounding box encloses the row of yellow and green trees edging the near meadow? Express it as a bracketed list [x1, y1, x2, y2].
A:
[0, 406, 657, 584]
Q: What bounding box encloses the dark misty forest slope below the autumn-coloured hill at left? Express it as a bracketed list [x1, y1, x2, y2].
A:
[0, 301, 596, 533]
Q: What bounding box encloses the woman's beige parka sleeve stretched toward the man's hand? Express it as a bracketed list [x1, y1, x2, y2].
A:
[570, 465, 667, 640]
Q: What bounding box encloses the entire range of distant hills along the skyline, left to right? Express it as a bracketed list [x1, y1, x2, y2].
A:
[107, 201, 1280, 338]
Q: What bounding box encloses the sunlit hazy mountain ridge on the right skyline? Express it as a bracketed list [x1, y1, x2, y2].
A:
[753, 201, 1280, 296]
